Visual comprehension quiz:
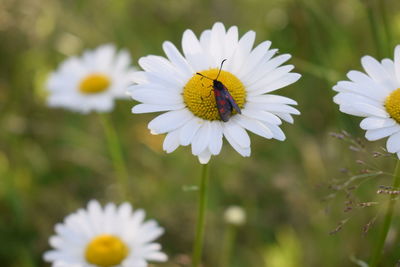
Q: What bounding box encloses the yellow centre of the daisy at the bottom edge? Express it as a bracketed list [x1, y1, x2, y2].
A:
[85, 235, 129, 267]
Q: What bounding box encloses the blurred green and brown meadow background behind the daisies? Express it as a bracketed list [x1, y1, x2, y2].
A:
[0, 0, 400, 267]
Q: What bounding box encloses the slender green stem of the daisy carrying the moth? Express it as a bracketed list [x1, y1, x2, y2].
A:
[192, 164, 209, 267]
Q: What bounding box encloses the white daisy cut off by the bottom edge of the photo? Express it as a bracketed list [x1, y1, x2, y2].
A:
[44, 200, 167, 267]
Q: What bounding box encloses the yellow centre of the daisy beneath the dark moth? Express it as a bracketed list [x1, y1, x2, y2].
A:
[183, 69, 246, 121]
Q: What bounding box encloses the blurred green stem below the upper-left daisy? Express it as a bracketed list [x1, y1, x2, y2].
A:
[99, 114, 129, 200]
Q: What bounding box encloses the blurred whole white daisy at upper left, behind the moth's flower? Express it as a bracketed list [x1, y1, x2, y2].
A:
[47, 45, 134, 113]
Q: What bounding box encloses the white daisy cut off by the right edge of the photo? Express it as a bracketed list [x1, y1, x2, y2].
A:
[333, 46, 400, 159]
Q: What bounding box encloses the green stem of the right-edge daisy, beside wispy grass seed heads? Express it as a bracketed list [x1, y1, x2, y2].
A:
[369, 160, 400, 267]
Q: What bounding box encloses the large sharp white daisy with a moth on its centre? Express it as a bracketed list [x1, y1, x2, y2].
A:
[129, 23, 300, 164]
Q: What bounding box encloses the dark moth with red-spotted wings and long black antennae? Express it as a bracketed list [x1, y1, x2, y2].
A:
[196, 59, 242, 122]
